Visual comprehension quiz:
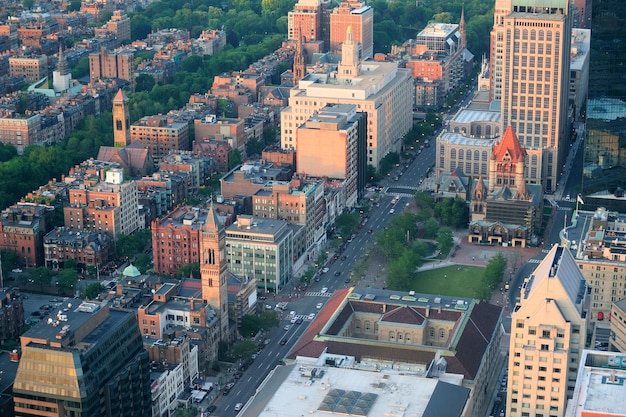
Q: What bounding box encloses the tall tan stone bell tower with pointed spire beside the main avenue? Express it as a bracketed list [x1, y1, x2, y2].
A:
[200, 202, 228, 340]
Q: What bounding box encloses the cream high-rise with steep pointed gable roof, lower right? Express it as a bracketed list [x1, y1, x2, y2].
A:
[506, 245, 590, 417]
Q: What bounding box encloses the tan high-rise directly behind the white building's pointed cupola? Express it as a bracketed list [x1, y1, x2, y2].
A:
[330, 0, 374, 60]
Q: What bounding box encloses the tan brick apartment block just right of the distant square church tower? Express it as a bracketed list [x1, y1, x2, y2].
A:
[130, 116, 189, 163]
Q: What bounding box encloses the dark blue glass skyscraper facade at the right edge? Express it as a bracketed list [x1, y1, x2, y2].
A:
[583, 0, 626, 202]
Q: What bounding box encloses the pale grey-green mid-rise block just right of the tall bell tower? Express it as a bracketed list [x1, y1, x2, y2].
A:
[226, 215, 294, 292]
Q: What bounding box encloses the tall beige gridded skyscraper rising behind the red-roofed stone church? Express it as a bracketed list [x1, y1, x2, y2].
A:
[491, 0, 572, 192]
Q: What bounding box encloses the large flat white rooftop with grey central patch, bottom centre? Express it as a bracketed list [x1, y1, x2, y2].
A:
[241, 357, 469, 417]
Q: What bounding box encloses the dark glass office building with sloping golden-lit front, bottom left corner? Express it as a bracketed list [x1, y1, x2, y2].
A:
[13, 300, 151, 417]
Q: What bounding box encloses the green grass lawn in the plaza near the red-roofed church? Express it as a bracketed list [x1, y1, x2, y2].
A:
[411, 265, 485, 298]
